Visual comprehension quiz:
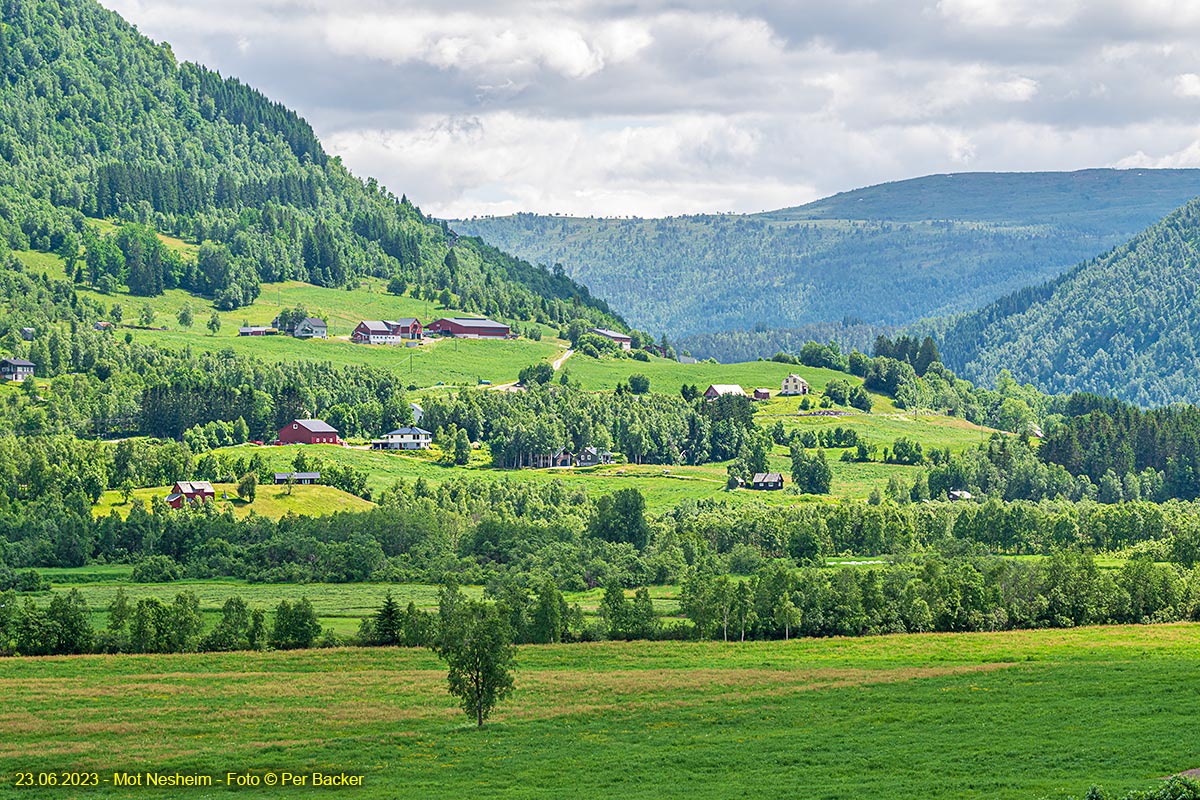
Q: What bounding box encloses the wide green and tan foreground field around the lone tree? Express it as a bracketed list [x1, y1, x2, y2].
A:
[0, 625, 1200, 800]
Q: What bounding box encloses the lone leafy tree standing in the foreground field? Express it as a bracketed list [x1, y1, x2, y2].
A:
[433, 601, 517, 728]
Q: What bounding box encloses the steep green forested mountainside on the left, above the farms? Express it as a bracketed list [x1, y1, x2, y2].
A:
[0, 0, 619, 324]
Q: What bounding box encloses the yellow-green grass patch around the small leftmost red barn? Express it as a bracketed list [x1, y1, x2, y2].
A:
[92, 484, 373, 519]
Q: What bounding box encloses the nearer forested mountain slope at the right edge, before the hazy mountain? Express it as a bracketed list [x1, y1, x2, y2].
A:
[938, 200, 1200, 405]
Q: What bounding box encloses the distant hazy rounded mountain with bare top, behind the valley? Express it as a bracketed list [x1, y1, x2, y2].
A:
[452, 169, 1200, 340]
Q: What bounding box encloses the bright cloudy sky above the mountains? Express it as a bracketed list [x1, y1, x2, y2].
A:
[102, 0, 1200, 217]
